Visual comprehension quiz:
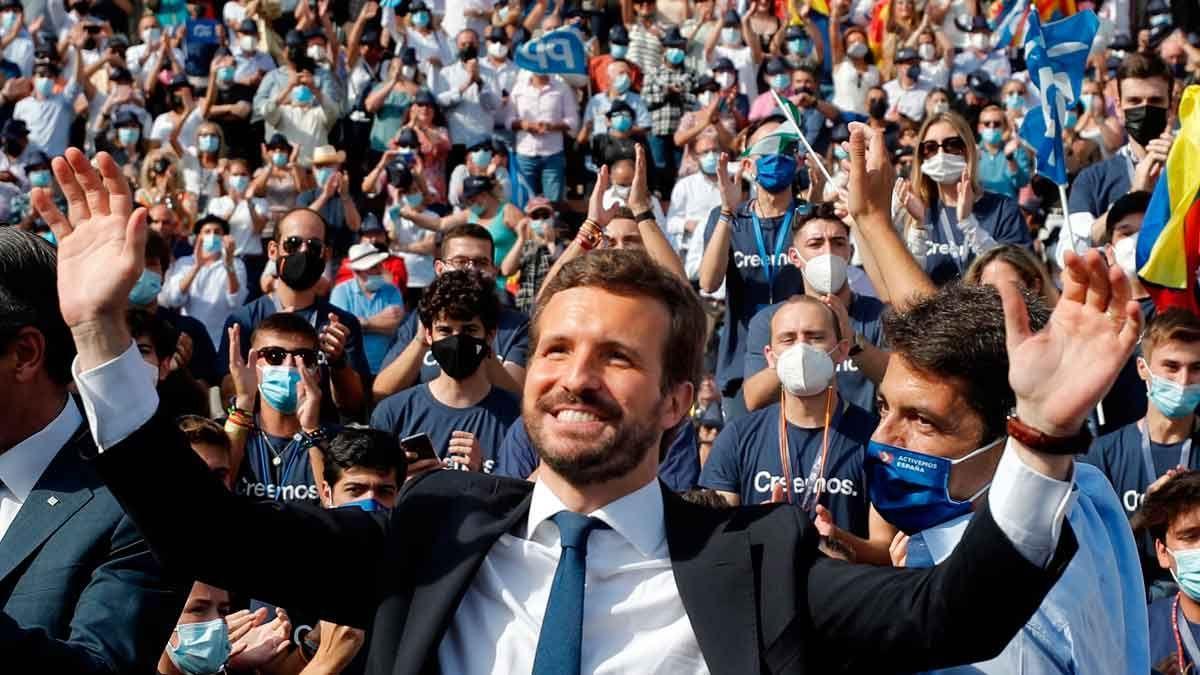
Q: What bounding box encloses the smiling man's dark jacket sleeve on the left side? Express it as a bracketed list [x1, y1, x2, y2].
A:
[95, 414, 397, 629]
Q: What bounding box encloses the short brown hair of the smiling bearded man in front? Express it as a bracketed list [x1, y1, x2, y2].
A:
[529, 249, 707, 392]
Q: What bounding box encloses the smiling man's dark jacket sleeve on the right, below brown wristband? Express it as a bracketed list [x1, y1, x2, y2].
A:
[799, 506, 1078, 673]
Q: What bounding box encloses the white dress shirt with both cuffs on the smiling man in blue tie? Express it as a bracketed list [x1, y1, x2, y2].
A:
[79, 342, 1074, 674]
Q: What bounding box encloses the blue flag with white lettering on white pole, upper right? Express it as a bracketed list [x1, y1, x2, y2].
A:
[1021, 11, 1100, 185]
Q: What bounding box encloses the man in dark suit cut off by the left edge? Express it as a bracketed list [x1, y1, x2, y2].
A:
[0, 228, 184, 673]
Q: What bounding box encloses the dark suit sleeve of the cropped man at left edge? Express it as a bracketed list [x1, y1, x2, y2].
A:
[0, 518, 186, 675]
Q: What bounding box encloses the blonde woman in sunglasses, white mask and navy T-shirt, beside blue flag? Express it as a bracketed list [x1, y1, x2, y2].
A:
[898, 112, 1033, 285]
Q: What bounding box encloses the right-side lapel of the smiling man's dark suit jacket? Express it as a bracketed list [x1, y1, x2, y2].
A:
[662, 489, 761, 675]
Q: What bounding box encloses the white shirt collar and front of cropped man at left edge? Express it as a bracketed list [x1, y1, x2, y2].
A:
[0, 396, 81, 544]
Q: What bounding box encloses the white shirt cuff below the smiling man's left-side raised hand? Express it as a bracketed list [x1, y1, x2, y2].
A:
[71, 342, 158, 452]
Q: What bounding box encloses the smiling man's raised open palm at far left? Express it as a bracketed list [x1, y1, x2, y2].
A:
[31, 148, 146, 370]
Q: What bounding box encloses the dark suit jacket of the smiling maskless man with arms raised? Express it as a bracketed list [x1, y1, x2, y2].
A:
[97, 418, 1076, 675]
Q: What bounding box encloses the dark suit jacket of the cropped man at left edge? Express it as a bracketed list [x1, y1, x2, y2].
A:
[0, 424, 186, 674]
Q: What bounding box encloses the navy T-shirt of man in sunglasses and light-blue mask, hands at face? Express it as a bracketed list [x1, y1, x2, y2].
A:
[234, 431, 320, 502]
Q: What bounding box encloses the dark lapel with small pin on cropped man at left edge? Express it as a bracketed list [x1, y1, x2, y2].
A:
[0, 425, 92, 581]
